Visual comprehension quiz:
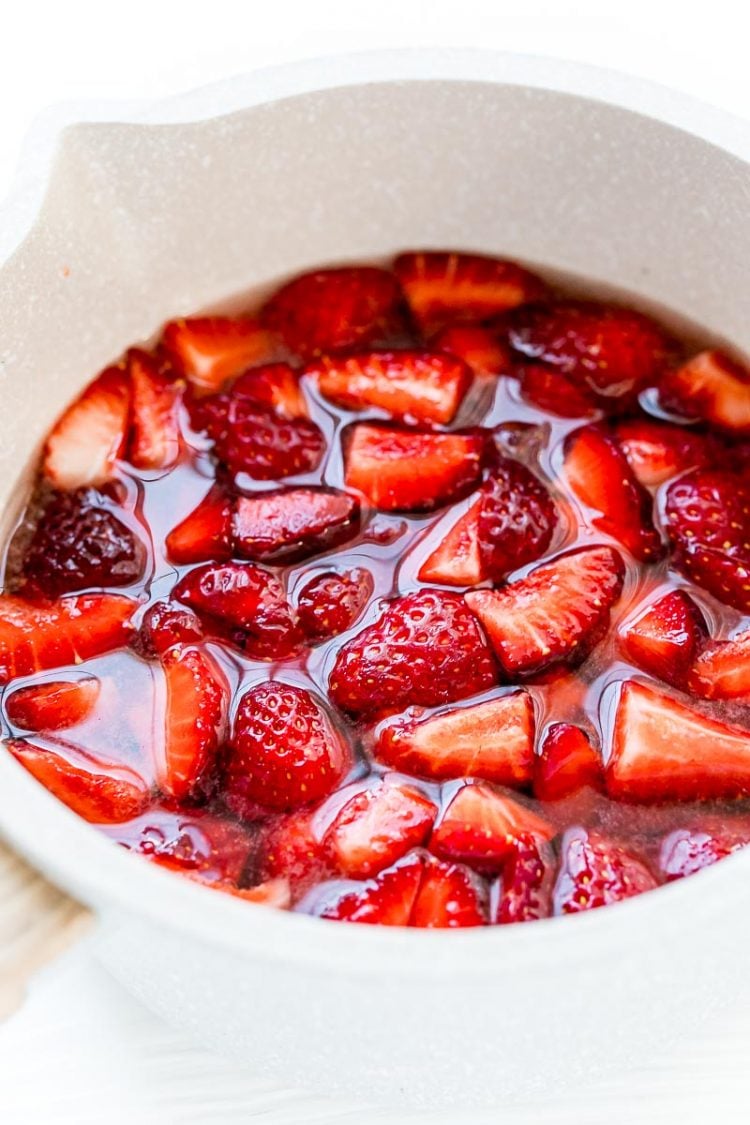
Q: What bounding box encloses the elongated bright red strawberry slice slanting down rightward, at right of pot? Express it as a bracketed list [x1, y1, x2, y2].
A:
[563, 425, 662, 563]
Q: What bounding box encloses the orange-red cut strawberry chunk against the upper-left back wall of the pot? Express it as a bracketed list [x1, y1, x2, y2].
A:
[162, 316, 280, 395]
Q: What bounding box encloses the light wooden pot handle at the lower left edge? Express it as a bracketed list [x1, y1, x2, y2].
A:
[0, 843, 92, 1020]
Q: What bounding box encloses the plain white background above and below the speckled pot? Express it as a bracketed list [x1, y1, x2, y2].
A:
[0, 0, 750, 1125]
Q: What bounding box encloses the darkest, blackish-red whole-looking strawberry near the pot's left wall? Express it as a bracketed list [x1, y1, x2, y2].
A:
[24, 488, 146, 599]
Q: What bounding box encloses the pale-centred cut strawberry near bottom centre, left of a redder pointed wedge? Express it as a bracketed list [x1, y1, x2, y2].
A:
[324, 780, 437, 879]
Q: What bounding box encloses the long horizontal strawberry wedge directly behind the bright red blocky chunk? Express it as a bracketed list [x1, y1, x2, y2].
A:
[305, 350, 472, 423]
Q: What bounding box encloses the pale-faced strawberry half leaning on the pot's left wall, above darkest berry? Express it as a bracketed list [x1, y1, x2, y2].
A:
[42, 367, 130, 492]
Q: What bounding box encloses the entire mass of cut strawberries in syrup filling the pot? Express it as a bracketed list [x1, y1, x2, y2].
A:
[0, 251, 750, 927]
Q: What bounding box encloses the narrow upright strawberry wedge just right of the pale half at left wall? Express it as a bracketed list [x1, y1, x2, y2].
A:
[127, 348, 180, 469]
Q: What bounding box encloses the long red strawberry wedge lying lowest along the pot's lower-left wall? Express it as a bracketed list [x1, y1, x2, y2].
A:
[6, 739, 151, 825]
